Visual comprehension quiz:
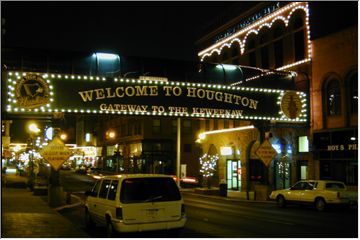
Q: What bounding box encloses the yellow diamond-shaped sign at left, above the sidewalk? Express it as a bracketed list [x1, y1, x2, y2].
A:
[40, 137, 71, 171]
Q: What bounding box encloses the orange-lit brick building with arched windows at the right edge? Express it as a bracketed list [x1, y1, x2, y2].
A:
[311, 27, 358, 188]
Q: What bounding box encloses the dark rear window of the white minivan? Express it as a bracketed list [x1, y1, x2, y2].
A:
[120, 177, 181, 203]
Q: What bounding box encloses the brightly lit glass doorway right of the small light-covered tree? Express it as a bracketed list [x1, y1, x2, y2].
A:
[226, 160, 241, 191]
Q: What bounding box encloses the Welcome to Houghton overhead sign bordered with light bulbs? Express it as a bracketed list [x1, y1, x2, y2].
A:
[3, 72, 307, 123]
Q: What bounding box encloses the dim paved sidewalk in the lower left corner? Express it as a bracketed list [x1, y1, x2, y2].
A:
[1, 174, 89, 238]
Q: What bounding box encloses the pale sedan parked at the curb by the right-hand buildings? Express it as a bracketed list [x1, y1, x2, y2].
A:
[270, 180, 357, 211]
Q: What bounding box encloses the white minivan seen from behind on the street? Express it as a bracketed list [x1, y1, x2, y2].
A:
[85, 174, 186, 236]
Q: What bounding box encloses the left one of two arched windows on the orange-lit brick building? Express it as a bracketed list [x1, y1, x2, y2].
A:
[326, 79, 341, 116]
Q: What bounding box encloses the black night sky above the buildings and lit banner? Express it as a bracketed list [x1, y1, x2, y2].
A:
[1, 1, 358, 61]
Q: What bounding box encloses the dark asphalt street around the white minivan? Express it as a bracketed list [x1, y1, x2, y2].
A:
[60, 171, 358, 238]
